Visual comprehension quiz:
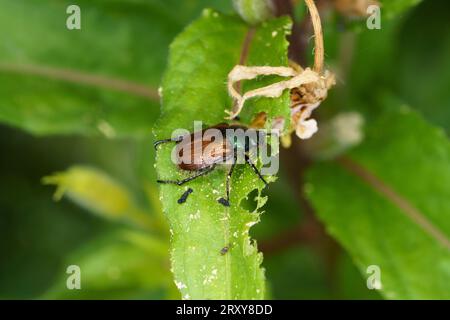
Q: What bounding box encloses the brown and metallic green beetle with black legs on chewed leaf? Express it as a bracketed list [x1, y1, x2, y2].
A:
[154, 123, 270, 207]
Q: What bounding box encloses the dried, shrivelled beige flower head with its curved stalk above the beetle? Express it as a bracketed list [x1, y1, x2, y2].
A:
[227, 0, 335, 145]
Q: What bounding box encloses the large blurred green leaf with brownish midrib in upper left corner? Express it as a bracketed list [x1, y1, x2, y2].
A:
[0, 0, 230, 137]
